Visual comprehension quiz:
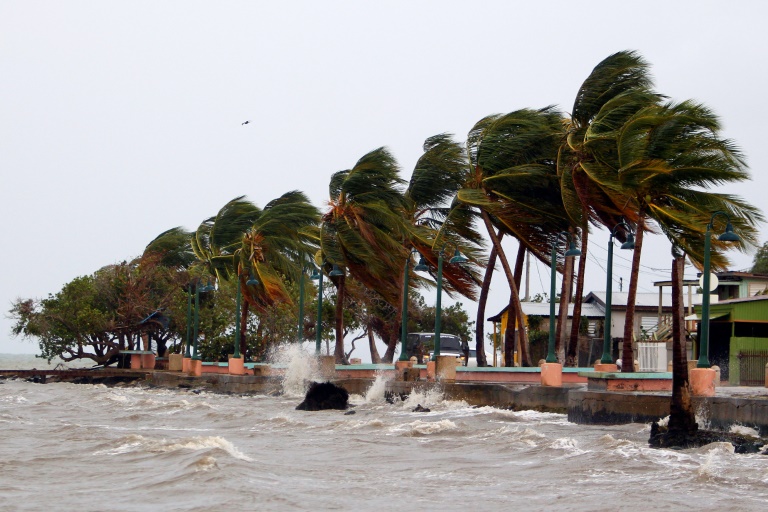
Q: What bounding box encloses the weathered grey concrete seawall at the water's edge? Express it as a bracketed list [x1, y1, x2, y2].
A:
[147, 371, 768, 436]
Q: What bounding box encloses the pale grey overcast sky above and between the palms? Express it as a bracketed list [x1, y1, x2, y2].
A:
[0, 0, 768, 357]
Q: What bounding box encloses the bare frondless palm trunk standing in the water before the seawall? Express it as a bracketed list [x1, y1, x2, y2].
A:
[668, 250, 698, 435]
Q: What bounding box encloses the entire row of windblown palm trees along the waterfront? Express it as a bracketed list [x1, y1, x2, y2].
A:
[146, 51, 762, 376]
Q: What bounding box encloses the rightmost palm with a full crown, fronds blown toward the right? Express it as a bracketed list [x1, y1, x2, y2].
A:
[616, 101, 762, 371]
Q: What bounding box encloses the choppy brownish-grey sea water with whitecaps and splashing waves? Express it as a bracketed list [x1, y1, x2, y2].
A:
[0, 354, 768, 512]
